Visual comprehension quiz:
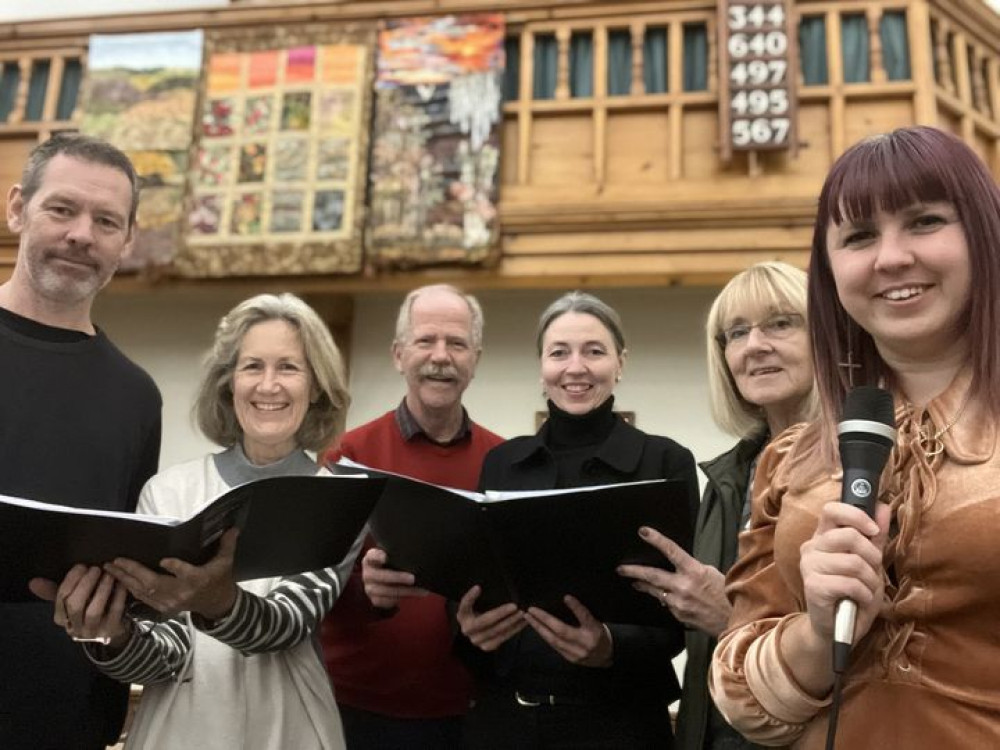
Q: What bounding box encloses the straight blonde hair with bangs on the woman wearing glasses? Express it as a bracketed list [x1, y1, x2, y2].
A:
[705, 261, 819, 438]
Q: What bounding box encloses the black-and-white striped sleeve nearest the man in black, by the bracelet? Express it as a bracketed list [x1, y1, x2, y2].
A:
[84, 617, 191, 685]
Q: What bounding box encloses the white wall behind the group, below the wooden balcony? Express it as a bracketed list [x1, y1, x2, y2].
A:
[95, 288, 732, 478]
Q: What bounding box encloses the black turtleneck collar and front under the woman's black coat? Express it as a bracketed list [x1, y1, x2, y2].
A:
[544, 396, 619, 489]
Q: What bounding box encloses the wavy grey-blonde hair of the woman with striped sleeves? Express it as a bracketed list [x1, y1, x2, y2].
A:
[194, 293, 351, 451]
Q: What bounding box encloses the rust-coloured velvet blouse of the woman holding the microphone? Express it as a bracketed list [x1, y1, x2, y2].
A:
[710, 372, 1000, 750]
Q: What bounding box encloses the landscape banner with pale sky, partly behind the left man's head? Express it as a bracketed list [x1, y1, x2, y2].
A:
[80, 31, 203, 271]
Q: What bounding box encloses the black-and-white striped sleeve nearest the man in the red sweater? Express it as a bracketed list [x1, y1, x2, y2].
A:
[191, 532, 364, 654]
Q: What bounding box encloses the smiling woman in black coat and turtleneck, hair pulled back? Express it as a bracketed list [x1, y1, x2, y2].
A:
[458, 292, 698, 750]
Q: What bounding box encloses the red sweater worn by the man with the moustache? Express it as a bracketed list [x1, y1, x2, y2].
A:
[321, 411, 503, 719]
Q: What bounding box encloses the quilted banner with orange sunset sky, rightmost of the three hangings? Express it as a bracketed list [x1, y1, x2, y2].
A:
[366, 13, 504, 267]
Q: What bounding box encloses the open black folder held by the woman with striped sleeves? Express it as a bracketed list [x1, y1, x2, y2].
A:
[0, 476, 385, 601]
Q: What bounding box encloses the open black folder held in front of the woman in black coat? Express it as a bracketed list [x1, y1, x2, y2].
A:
[370, 475, 693, 625]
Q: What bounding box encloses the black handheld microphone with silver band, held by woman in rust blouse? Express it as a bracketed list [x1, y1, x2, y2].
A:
[833, 386, 896, 674]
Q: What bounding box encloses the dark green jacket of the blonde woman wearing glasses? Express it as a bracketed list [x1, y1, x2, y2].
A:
[677, 432, 767, 750]
